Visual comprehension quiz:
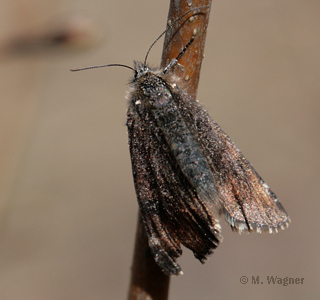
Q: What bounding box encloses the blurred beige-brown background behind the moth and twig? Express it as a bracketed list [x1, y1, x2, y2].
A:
[0, 0, 320, 300]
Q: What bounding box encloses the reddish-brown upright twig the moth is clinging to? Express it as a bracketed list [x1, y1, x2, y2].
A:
[128, 0, 211, 300]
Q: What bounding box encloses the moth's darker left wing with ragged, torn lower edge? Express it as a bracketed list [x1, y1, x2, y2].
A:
[127, 99, 221, 274]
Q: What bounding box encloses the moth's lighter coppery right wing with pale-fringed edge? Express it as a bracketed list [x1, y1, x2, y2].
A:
[175, 91, 290, 233]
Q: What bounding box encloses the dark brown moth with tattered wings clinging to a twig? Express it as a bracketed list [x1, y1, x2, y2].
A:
[72, 10, 290, 275]
